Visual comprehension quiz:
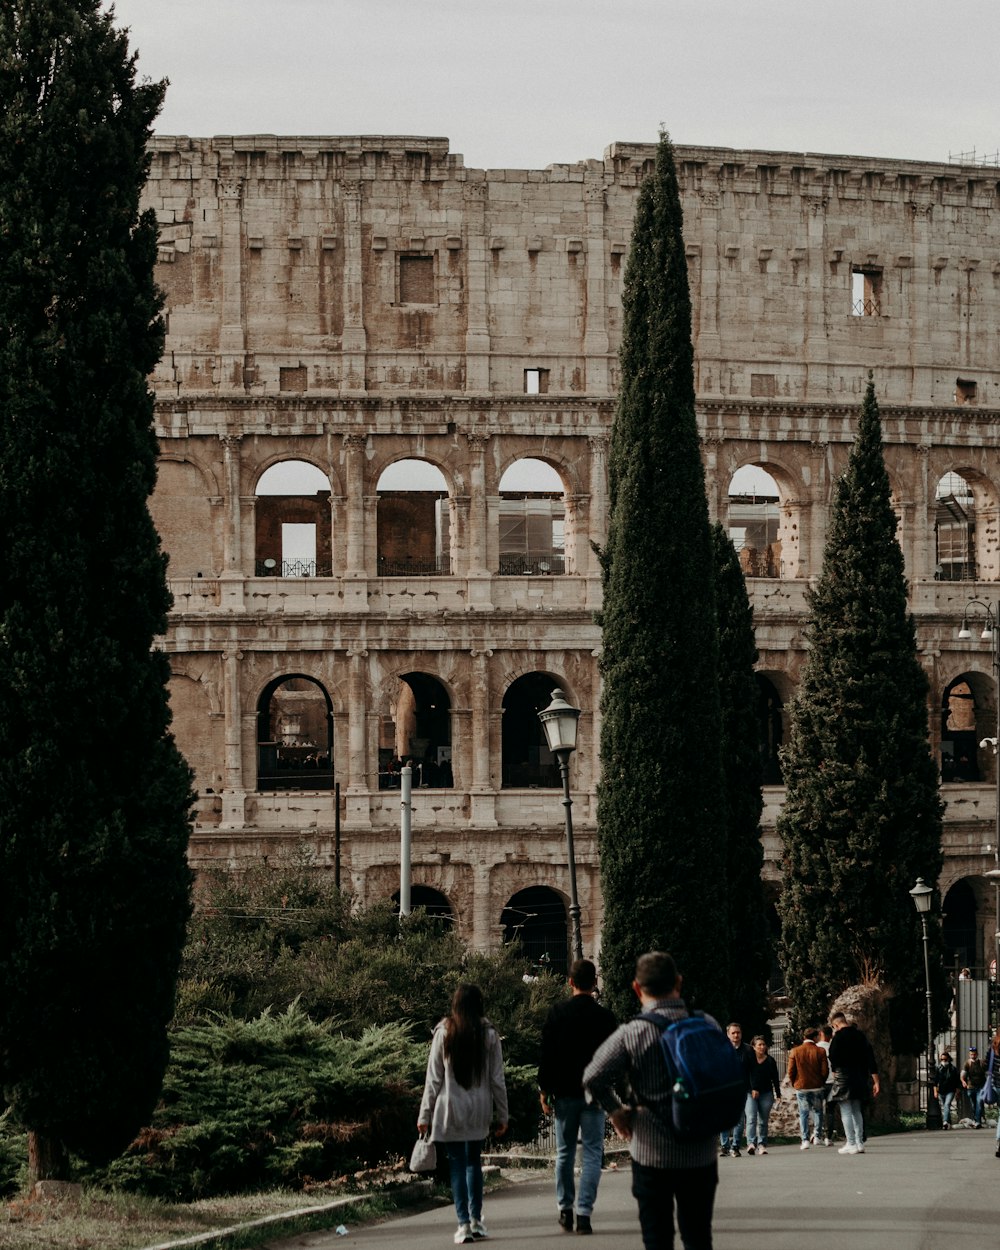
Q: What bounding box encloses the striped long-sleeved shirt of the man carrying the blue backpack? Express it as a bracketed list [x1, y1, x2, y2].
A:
[584, 998, 719, 1169]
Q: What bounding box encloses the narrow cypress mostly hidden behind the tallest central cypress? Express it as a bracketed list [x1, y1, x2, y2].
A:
[713, 525, 771, 1038]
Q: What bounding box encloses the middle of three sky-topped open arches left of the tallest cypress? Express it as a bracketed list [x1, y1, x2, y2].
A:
[376, 460, 451, 578]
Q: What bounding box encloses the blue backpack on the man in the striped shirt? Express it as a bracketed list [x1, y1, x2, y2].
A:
[636, 1011, 746, 1141]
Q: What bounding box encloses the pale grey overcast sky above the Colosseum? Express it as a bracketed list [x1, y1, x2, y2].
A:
[105, 0, 1000, 169]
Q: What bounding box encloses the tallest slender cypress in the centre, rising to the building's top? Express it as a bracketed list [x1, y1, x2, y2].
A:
[598, 135, 729, 1016]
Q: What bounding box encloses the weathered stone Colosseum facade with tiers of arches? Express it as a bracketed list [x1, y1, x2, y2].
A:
[146, 136, 1000, 965]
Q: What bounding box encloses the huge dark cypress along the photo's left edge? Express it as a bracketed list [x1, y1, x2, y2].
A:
[0, 0, 191, 1176]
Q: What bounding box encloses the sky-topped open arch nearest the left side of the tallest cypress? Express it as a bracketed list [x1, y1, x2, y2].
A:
[499, 456, 566, 576]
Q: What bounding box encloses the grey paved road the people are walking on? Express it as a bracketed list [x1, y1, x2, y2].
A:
[274, 1130, 1000, 1250]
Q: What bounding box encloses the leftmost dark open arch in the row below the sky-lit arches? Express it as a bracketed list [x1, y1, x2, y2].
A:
[258, 675, 334, 790]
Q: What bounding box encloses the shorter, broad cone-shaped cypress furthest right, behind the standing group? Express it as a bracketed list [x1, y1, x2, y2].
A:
[778, 375, 941, 1040]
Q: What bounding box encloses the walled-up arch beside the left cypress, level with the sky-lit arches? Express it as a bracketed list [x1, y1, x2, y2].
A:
[149, 456, 223, 578]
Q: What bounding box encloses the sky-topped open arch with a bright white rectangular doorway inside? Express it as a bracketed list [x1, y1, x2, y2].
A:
[254, 460, 334, 578]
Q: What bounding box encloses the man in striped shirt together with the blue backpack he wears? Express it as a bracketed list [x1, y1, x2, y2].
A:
[584, 950, 745, 1250]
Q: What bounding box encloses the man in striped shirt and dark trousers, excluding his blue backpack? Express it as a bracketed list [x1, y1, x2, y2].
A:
[584, 950, 719, 1250]
